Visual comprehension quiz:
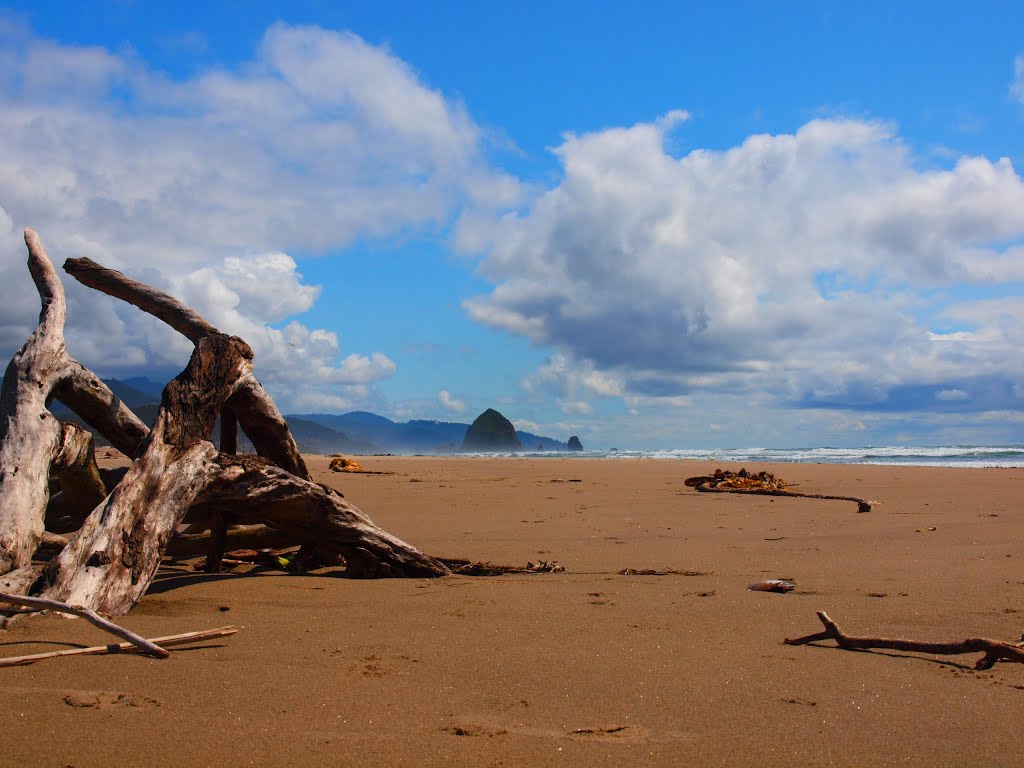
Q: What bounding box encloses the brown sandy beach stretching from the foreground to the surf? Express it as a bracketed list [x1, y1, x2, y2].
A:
[0, 457, 1024, 768]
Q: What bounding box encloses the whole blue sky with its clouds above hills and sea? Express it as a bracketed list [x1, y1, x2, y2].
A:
[0, 0, 1024, 450]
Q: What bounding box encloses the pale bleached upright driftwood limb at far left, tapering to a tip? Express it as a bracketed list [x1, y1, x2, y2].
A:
[0, 229, 68, 574]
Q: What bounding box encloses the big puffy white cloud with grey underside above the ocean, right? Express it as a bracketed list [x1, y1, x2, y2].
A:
[465, 119, 1024, 423]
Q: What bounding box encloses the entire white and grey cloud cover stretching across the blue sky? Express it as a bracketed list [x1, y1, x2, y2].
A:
[0, 18, 1024, 439]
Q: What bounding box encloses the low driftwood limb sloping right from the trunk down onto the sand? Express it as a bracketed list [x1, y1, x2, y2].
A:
[196, 454, 451, 578]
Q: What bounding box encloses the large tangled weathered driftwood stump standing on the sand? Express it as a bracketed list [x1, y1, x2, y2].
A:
[0, 230, 450, 614]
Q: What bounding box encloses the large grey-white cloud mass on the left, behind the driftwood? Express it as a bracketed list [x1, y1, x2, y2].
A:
[0, 22, 519, 409]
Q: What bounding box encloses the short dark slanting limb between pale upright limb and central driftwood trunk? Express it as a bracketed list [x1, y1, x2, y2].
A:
[53, 359, 150, 457]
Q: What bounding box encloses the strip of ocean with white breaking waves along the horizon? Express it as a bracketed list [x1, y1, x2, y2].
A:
[471, 445, 1024, 467]
